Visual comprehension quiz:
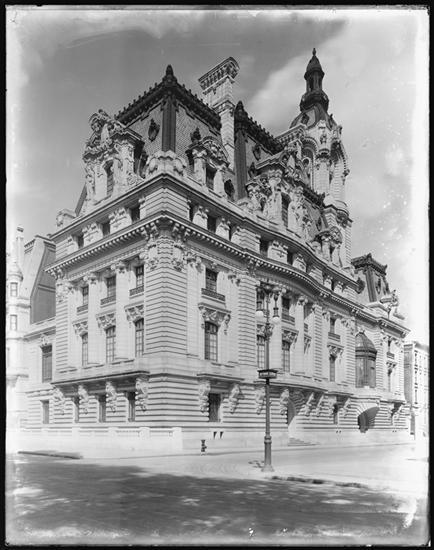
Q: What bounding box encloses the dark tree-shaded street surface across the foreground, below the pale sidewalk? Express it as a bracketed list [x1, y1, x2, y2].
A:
[6, 456, 428, 545]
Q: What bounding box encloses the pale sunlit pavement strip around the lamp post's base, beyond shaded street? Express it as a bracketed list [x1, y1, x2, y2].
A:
[73, 444, 428, 497]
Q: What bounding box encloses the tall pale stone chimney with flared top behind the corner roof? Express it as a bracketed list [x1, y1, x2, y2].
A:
[199, 57, 240, 169]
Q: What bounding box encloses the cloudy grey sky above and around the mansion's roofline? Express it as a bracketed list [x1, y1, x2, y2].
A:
[6, 6, 429, 342]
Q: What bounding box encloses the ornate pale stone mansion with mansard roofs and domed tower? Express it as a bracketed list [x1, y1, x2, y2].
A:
[7, 51, 409, 458]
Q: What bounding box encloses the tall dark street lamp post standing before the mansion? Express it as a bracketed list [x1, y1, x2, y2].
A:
[256, 281, 279, 472]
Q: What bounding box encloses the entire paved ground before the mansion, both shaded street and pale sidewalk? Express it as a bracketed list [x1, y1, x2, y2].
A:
[7, 446, 429, 545]
